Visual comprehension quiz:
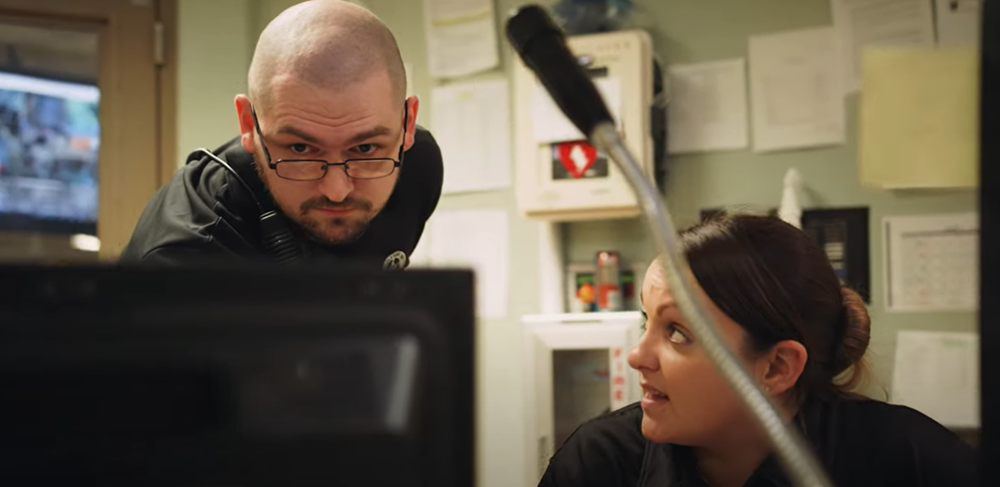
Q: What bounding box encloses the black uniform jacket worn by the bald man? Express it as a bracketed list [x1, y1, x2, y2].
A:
[120, 127, 444, 267]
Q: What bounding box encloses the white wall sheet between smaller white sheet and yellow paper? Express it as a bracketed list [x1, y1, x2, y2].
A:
[750, 27, 844, 152]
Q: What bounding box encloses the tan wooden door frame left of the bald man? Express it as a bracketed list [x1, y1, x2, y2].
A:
[0, 0, 178, 260]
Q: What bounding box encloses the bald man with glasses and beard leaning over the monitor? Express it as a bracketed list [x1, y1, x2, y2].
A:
[121, 0, 443, 268]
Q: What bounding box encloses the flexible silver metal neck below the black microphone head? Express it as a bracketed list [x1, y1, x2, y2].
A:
[590, 122, 833, 487]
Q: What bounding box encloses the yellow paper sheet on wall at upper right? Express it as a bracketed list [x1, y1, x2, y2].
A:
[858, 47, 979, 189]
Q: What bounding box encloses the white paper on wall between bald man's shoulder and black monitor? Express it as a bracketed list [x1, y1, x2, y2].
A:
[411, 210, 510, 320]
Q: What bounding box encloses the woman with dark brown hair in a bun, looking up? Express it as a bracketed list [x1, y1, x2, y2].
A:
[539, 215, 977, 487]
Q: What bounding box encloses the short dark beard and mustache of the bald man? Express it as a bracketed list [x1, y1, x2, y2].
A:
[254, 151, 378, 245]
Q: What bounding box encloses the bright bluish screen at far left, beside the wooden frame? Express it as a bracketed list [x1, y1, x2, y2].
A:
[0, 71, 101, 234]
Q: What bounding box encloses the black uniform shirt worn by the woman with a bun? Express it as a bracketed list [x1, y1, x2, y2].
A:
[538, 399, 979, 487]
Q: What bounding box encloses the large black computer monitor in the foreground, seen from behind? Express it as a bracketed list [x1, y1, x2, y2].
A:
[0, 267, 474, 487]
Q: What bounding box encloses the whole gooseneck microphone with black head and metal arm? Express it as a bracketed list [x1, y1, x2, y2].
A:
[507, 6, 833, 487]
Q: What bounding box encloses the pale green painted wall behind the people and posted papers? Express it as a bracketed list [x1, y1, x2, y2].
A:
[178, 0, 976, 487]
